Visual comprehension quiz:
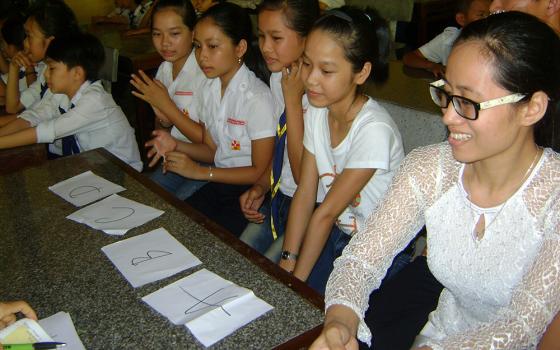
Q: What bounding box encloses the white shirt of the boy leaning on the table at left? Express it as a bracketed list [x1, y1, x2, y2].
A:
[20, 81, 142, 171]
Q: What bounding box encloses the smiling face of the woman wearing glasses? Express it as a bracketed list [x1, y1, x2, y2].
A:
[443, 41, 532, 163]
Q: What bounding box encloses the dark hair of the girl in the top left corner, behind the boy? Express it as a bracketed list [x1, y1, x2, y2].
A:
[28, 0, 80, 38]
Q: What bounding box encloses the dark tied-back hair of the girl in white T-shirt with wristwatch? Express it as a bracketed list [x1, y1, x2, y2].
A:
[312, 6, 390, 83]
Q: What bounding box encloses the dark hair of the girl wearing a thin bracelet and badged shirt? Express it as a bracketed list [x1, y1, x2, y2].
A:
[199, 2, 270, 84]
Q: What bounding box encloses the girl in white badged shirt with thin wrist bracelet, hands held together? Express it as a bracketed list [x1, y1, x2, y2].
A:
[148, 3, 276, 236]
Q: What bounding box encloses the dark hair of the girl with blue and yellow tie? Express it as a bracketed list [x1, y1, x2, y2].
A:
[257, 0, 320, 37]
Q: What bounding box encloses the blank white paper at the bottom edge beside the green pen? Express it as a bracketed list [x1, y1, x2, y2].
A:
[39, 311, 86, 350]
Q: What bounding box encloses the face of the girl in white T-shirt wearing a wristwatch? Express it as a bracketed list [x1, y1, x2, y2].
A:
[301, 30, 367, 109]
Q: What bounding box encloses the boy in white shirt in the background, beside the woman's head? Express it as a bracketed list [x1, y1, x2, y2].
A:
[403, 0, 490, 78]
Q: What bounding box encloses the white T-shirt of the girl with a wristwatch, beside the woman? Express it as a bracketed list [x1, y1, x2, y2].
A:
[303, 98, 404, 235]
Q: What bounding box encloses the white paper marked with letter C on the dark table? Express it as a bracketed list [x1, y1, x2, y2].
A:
[66, 194, 164, 235]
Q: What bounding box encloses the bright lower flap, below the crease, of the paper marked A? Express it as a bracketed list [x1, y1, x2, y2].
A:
[185, 292, 273, 347]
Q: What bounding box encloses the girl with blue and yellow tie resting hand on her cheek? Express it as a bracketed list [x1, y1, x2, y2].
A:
[239, 0, 322, 262]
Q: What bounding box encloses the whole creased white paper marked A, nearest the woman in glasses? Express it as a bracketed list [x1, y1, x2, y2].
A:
[142, 269, 273, 346]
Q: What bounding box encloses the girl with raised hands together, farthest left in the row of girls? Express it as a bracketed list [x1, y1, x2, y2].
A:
[131, 0, 210, 200]
